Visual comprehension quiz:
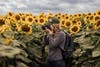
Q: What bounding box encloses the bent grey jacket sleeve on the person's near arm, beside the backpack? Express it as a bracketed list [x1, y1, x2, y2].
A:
[49, 33, 65, 47]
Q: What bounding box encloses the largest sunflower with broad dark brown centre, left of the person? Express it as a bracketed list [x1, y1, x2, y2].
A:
[19, 24, 32, 34]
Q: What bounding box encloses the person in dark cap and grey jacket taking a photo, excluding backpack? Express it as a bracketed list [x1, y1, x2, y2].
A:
[43, 18, 65, 67]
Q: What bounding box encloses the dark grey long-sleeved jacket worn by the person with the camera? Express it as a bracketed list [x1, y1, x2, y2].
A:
[43, 31, 66, 61]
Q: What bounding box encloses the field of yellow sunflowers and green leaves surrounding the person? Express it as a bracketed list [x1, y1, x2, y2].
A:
[0, 10, 100, 67]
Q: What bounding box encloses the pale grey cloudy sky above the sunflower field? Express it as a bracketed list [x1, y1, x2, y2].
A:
[0, 0, 100, 14]
